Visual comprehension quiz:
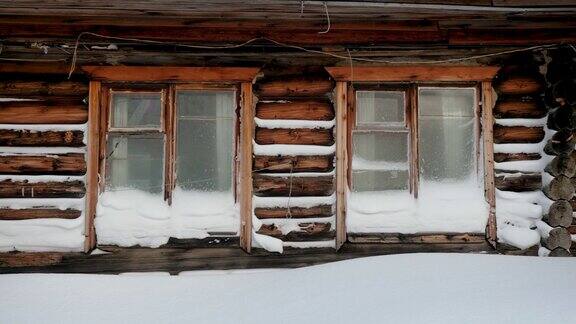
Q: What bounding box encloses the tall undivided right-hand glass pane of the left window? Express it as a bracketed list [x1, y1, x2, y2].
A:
[176, 91, 236, 191]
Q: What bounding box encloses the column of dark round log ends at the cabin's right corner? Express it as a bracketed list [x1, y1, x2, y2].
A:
[542, 49, 576, 256]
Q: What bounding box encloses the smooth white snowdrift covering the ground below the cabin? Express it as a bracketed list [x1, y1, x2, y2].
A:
[0, 254, 576, 324]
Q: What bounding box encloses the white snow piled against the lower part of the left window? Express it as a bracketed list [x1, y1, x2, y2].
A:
[95, 188, 239, 247]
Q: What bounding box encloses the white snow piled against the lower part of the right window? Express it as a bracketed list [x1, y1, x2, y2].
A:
[346, 183, 488, 234]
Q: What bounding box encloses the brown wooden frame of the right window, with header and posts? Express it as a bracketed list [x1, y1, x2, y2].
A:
[326, 65, 499, 248]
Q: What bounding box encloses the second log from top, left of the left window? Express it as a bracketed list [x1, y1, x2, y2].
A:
[0, 101, 88, 124]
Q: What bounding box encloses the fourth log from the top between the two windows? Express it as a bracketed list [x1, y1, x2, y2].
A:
[253, 155, 334, 173]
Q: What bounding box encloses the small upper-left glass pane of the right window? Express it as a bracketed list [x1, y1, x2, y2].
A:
[356, 91, 404, 125]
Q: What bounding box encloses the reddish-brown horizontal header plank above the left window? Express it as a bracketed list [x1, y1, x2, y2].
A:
[82, 66, 260, 83]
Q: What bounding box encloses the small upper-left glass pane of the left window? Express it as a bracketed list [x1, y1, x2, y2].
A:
[112, 92, 162, 128]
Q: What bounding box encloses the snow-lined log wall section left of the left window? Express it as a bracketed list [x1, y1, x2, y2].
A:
[0, 73, 88, 251]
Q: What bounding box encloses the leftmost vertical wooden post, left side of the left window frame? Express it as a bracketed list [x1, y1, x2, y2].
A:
[84, 81, 101, 252]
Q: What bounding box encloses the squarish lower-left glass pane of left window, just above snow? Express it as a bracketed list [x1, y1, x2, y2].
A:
[106, 134, 164, 193]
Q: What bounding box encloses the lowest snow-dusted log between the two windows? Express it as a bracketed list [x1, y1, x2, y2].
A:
[257, 222, 335, 242]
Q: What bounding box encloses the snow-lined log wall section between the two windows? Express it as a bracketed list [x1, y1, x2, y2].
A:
[253, 67, 335, 245]
